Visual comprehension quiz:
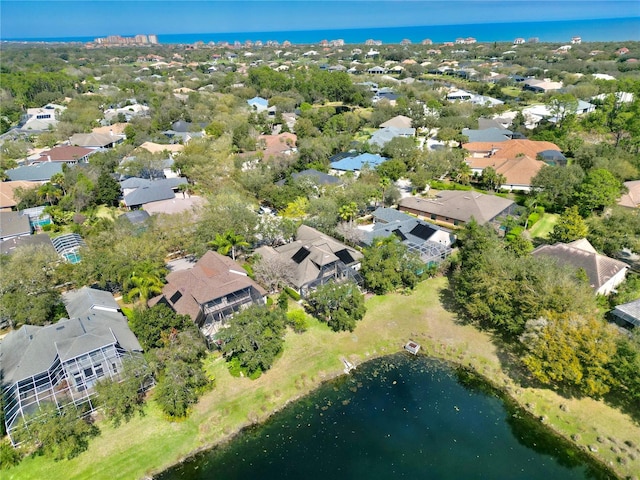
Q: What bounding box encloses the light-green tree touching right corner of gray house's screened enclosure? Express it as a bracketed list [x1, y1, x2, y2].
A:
[96, 356, 152, 427]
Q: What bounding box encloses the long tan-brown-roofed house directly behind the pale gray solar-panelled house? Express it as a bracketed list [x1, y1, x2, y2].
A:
[398, 190, 517, 226]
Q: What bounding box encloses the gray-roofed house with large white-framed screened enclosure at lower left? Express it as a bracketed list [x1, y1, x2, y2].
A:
[0, 287, 144, 444]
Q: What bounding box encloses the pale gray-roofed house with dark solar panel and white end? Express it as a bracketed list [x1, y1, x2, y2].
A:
[358, 207, 455, 265]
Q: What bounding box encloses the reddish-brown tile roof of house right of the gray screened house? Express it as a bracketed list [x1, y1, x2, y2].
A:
[153, 251, 267, 321]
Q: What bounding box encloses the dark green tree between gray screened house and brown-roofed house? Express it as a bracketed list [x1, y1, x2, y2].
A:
[129, 304, 196, 350]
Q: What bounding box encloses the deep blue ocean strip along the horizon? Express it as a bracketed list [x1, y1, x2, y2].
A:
[6, 17, 640, 44]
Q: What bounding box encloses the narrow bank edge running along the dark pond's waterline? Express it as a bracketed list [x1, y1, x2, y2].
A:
[150, 348, 629, 480]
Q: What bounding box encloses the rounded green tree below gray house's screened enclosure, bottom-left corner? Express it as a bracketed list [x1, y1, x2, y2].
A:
[14, 403, 100, 460]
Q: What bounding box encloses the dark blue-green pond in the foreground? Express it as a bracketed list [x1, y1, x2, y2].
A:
[157, 353, 609, 480]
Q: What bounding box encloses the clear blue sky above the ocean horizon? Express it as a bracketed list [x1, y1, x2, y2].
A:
[0, 0, 640, 40]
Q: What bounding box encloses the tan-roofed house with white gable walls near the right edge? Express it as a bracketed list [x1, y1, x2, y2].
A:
[531, 238, 629, 295]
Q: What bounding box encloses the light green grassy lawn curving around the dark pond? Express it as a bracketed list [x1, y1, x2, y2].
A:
[7, 278, 640, 480]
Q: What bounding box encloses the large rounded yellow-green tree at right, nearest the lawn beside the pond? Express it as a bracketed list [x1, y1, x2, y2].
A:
[520, 311, 616, 398]
